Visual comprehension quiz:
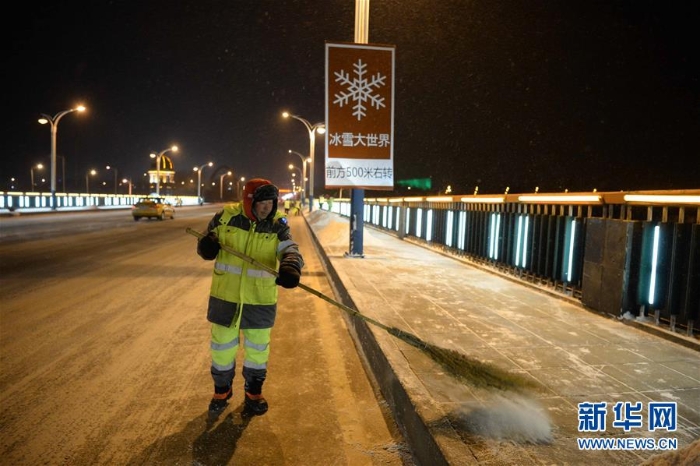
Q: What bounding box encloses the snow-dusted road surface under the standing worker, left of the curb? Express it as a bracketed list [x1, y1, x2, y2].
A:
[0, 206, 411, 465]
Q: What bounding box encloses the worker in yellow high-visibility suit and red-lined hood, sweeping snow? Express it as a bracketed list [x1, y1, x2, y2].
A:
[197, 178, 304, 417]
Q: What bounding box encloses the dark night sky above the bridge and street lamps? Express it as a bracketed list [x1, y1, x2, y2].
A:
[6, 0, 700, 197]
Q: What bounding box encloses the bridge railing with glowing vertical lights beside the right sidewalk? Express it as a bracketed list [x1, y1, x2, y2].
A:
[322, 189, 700, 335]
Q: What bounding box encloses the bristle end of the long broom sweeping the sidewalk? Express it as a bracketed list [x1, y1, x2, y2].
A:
[387, 327, 536, 390]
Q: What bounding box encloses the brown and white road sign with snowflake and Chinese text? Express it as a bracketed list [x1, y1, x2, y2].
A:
[325, 42, 395, 189]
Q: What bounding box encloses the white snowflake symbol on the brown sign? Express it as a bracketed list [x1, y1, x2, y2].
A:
[333, 59, 386, 121]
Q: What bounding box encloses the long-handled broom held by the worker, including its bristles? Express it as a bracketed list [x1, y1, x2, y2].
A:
[185, 227, 536, 390]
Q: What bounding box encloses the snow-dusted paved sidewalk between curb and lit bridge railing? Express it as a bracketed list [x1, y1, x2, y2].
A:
[304, 211, 700, 465]
